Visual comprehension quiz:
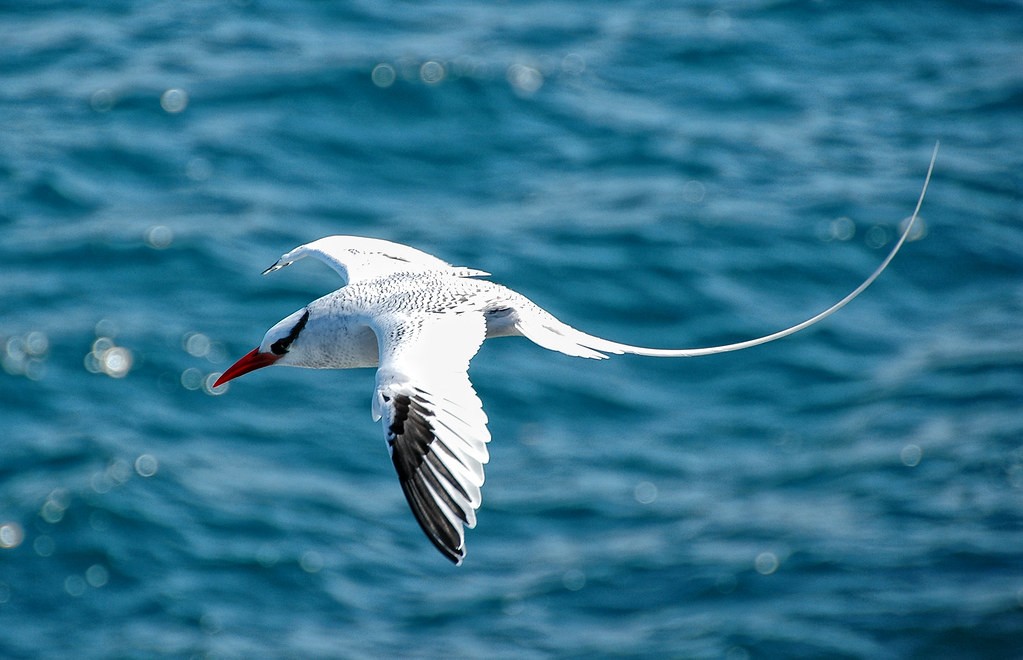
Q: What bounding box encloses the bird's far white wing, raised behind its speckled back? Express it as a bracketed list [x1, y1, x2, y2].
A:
[263, 235, 490, 283]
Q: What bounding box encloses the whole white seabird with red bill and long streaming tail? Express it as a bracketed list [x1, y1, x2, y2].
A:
[215, 143, 937, 563]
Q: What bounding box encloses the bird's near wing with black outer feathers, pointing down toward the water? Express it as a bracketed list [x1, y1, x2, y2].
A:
[373, 311, 490, 564]
